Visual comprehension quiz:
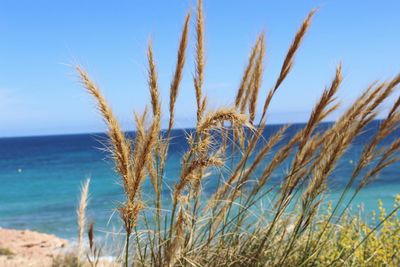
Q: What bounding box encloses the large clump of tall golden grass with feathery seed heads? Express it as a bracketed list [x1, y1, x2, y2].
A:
[72, 1, 400, 266]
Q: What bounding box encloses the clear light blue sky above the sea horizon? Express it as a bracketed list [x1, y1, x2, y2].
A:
[0, 0, 400, 137]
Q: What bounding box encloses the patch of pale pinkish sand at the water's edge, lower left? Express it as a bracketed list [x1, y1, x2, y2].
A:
[0, 228, 68, 267]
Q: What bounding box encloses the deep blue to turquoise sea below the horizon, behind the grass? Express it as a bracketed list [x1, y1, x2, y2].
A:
[0, 121, 400, 239]
